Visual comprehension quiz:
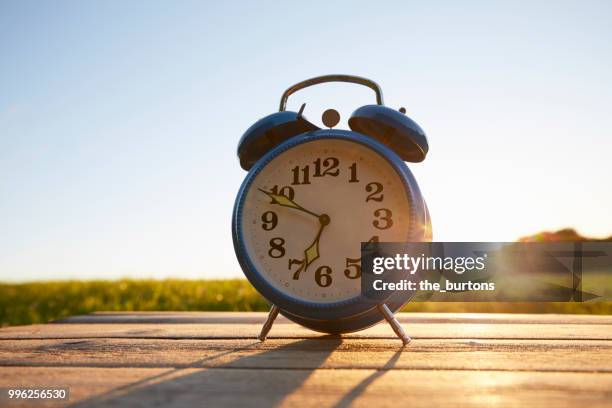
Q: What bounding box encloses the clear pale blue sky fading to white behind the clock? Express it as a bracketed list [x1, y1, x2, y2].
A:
[0, 0, 612, 281]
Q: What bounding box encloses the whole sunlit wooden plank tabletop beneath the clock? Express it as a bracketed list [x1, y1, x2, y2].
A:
[0, 312, 612, 408]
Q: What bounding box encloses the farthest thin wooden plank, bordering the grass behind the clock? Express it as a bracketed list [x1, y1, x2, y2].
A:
[55, 312, 612, 325]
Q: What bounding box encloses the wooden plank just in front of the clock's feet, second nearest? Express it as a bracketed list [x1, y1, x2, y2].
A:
[0, 338, 612, 372]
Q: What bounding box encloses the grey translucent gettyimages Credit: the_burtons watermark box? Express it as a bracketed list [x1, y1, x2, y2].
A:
[361, 242, 612, 302]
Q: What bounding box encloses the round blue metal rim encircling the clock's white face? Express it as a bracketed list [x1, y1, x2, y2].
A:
[232, 129, 425, 322]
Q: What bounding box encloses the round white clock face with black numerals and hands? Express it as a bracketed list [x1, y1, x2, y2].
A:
[240, 138, 411, 303]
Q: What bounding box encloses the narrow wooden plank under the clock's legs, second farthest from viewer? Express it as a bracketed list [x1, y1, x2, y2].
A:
[0, 323, 612, 340]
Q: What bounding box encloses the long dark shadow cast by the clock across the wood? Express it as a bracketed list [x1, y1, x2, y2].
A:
[72, 336, 401, 407]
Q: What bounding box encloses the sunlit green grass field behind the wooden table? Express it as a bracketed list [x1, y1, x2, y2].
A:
[0, 279, 612, 326]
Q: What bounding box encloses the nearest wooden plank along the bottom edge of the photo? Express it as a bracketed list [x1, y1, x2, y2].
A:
[0, 367, 612, 408]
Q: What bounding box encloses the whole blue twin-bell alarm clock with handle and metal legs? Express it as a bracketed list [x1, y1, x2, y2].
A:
[232, 75, 431, 344]
